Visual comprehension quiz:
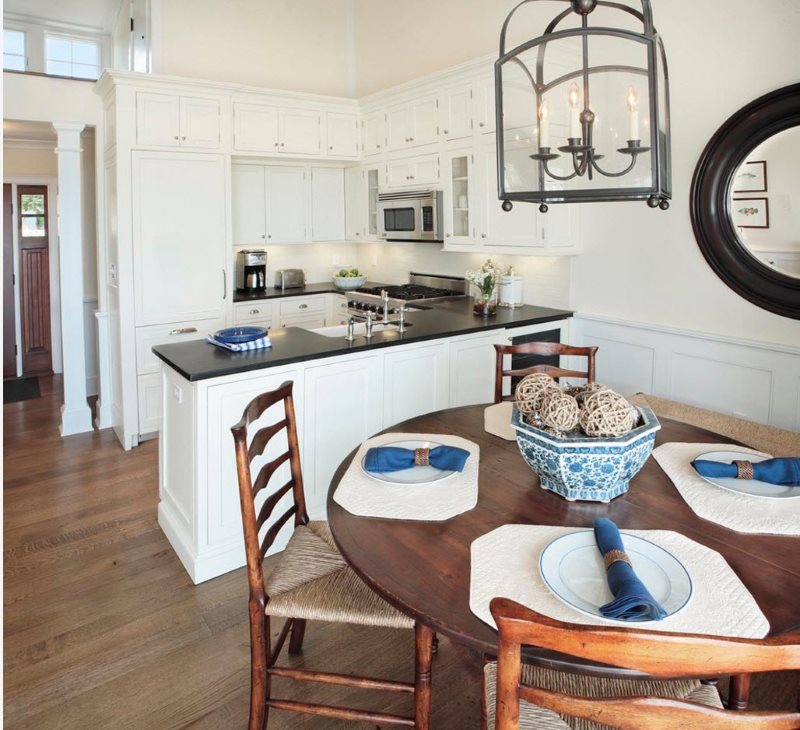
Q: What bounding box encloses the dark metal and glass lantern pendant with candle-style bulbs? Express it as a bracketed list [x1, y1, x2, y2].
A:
[495, 0, 672, 213]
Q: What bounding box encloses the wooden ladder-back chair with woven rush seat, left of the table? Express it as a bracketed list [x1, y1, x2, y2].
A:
[231, 382, 434, 730]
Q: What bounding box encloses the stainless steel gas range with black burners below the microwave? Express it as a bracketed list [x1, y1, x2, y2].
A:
[347, 271, 467, 318]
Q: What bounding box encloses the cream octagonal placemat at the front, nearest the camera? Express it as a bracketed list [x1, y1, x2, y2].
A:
[469, 525, 769, 639]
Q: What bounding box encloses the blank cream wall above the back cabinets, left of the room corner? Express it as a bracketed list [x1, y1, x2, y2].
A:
[153, 0, 355, 96]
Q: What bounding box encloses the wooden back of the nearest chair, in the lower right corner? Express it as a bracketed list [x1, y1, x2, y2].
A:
[487, 598, 800, 730]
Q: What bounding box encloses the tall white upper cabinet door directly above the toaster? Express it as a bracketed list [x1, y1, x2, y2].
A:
[266, 167, 307, 243]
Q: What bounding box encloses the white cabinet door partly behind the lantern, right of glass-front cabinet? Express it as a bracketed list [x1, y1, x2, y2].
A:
[478, 146, 543, 248]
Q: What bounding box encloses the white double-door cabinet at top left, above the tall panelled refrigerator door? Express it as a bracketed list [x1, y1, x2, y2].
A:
[136, 91, 221, 149]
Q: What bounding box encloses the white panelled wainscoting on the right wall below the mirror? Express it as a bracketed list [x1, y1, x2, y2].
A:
[571, 314, 800, 431]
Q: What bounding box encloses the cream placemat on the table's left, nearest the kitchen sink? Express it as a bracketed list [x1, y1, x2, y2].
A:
[333, 433, 480, 521]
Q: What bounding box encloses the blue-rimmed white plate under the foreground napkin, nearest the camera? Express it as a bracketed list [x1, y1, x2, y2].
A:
[539, 530, 692, 624]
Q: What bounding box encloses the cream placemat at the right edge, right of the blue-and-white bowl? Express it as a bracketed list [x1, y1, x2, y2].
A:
[653, 442, 800, 536]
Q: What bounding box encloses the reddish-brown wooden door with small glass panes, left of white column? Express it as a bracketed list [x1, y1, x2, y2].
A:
[17, 185, 53, 375]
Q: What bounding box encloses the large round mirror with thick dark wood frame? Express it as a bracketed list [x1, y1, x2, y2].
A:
[690, 84, 800, 319]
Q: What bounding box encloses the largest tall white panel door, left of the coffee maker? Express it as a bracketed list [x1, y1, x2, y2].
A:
[132, 151, 227, 326]
